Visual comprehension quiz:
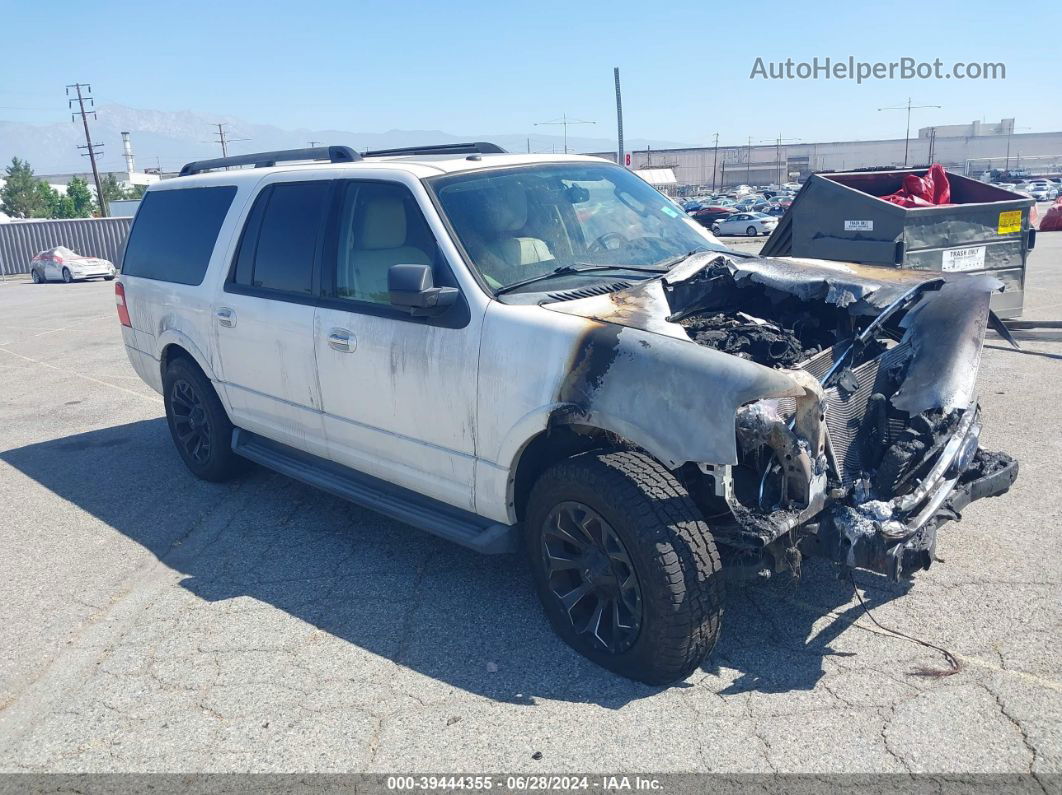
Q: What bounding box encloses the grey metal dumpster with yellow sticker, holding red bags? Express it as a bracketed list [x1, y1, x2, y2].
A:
[760, 169, 1035, 317]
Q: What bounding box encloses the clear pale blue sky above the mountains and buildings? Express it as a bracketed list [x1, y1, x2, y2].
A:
[0, 0, 1062, 144]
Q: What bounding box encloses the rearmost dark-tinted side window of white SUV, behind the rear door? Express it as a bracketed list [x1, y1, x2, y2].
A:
[122, 185, 236, 284]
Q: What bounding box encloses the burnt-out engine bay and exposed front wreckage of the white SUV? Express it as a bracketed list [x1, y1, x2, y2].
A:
[671, 260, 1017, 578]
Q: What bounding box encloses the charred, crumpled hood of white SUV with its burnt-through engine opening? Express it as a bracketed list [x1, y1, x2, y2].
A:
[544, 253, 1001, 415]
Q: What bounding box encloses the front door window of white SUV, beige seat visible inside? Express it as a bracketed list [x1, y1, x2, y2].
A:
[335, 180, 438, 305]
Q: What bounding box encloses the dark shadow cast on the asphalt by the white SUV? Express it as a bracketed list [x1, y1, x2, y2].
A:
[0, 418, 903, 708]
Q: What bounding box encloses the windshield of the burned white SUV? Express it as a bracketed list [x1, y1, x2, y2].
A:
[428, 162, 725, 291]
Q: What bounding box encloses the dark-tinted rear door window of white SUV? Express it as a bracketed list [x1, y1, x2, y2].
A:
[233, 182, 331, 295]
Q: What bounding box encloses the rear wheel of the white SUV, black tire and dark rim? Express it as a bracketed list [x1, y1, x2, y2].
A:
[162, 358, 245, 481]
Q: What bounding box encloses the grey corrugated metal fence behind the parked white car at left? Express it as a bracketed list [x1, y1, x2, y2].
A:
[0, 218, 133, 276]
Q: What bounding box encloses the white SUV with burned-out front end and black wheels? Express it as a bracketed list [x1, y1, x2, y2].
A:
[116, 143, 1017, 684]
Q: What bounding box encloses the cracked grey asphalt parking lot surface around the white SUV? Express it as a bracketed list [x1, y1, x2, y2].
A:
[0, 234, 1062, 773]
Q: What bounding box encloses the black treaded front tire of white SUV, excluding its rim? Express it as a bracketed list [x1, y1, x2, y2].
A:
[524, 451, 723, 685]
